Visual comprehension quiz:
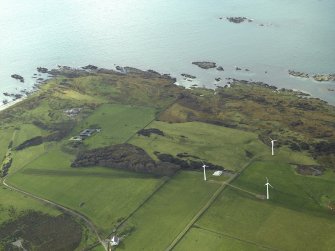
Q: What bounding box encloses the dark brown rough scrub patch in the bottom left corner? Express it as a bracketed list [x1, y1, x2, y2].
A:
[0, 211, 82, 251]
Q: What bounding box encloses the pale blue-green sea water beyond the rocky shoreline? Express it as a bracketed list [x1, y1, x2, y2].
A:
[0, 0, 335, 104]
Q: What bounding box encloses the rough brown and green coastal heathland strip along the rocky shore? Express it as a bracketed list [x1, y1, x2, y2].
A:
[0, 67, 335, 167]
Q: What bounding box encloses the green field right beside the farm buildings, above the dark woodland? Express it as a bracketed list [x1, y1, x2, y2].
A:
[73, 104, 155, 148]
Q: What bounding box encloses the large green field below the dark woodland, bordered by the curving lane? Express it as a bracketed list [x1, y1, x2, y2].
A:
[9, 161, 161, 234]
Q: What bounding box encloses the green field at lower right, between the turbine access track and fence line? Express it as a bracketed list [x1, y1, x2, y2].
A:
[192, 188, 335, 250]
